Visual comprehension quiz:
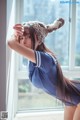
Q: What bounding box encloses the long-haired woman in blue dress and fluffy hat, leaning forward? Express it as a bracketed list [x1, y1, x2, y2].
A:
[8, 18, 80, 120]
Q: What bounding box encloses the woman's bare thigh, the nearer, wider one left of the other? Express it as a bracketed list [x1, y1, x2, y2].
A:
[64, 106, 77, 120]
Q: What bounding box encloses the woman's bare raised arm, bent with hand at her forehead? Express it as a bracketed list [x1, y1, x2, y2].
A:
[8, 23, 36, 63]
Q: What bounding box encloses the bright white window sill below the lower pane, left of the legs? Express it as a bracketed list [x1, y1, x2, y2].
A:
[14, 111, 64, 120]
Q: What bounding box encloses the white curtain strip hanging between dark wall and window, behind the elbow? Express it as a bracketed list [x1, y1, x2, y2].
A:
[6, 0, 15, 120]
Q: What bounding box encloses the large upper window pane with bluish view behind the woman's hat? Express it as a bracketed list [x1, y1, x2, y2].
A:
[19, 0, 69, 70]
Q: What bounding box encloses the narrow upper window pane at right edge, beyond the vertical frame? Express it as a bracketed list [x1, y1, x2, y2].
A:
[75, 4, 80, 66]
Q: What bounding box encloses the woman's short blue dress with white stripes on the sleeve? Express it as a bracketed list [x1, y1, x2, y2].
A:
[29, 51, 80, 106]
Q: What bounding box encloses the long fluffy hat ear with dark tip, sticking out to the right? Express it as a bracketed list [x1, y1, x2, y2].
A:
[46, 18, 64, 32]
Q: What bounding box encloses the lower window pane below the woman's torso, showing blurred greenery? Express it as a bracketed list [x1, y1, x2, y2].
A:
[18, 79, 62, 111]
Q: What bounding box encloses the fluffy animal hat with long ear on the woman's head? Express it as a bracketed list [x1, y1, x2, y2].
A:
[23, 18, 64, 42]
